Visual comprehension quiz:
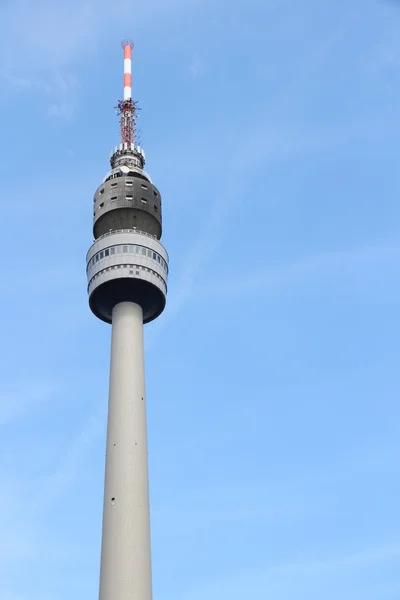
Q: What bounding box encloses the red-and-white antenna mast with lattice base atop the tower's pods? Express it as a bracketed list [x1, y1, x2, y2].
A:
[110, 40, 145, 169]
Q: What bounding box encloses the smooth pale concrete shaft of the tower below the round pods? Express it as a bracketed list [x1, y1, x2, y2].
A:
[99, 302, 152, 600]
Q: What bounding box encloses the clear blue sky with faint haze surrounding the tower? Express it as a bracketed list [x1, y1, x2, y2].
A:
[0, 0, 400, 600]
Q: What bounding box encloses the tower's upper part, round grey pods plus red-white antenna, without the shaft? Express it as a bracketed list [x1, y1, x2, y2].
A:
[86, 41, 168, 324]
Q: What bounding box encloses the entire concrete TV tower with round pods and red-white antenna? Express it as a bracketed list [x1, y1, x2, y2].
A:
[86, 40, 168, 600]
